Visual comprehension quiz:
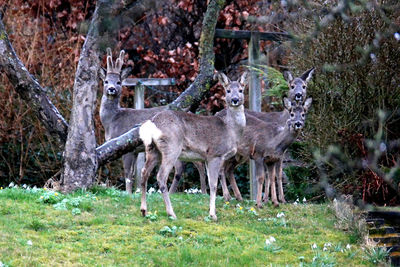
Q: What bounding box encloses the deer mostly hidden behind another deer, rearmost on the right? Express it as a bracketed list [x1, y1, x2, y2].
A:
[216, 68, 315, 203]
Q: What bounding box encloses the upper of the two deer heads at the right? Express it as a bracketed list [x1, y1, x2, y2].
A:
[284, 68, 314, 103]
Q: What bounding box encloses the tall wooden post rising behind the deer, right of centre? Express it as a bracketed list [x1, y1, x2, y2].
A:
[248, 33, 262, 200]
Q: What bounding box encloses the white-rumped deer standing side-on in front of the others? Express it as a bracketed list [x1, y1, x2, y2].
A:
[139, 72, 247, 220]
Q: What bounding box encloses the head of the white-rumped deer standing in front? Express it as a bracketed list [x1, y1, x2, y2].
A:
[217, 72, 247, 107]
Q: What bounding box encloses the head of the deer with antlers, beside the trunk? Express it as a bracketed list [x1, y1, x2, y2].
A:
[100, 48, 131, 99]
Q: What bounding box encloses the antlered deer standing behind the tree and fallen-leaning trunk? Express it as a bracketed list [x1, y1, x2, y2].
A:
[99, 48, 188, 194]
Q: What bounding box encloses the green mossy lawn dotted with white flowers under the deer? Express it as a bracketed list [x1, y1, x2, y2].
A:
[0, 188, 372, 266]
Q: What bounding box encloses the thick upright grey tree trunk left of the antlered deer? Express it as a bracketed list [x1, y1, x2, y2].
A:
[62, 1, 106, 192]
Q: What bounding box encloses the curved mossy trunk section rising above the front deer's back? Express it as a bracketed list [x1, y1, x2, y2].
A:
[169, 0, 225, 110]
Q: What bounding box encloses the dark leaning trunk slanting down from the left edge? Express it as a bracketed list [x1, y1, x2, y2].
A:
[0, 19, 68, 145]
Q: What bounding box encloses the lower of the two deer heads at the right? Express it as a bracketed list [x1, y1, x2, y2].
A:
[283, 97, 312, 132]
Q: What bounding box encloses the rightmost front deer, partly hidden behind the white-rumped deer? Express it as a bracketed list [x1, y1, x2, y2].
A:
[224, 97, 312, 208]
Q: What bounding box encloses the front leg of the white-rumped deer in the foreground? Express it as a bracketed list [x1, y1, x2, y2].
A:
[206, 158, 222, 221]
